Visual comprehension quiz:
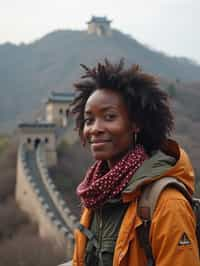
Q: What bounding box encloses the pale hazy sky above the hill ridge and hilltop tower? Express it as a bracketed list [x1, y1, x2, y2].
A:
[0, 0, 200, 63]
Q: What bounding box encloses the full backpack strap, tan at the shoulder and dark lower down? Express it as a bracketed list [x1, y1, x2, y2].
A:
[138, 177, 192, 266]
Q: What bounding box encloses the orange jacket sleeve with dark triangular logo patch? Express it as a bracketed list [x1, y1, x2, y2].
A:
[150, 188, 200, 266]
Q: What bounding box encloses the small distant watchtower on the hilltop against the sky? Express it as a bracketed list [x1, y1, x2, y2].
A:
[87, 16, 112, 36]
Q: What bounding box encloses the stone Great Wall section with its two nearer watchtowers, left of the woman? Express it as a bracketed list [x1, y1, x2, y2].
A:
[16, 92, 77, 258]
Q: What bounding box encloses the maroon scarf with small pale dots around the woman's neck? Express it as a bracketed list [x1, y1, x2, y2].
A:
[77, 145, 148, 208]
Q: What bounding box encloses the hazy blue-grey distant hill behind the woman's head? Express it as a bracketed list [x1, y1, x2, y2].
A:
[0, 30, 200, 130]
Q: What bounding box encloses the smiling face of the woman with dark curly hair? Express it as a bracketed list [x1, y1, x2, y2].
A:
[83, 89, 136, 167]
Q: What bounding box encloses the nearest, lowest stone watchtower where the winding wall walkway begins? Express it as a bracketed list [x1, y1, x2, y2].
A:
[18, 121, 57, 166]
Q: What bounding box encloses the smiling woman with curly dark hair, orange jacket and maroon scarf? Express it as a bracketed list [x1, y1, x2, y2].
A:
[72, 60, 200, 266]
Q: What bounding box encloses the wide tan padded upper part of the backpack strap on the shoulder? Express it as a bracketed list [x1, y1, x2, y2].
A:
[138, 177, 192, 220]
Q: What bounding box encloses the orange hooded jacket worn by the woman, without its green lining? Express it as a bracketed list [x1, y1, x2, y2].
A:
[73, 141, 200, 266]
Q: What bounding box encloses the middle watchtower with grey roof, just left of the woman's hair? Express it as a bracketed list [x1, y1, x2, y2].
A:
[46, 92, 74, 127]
